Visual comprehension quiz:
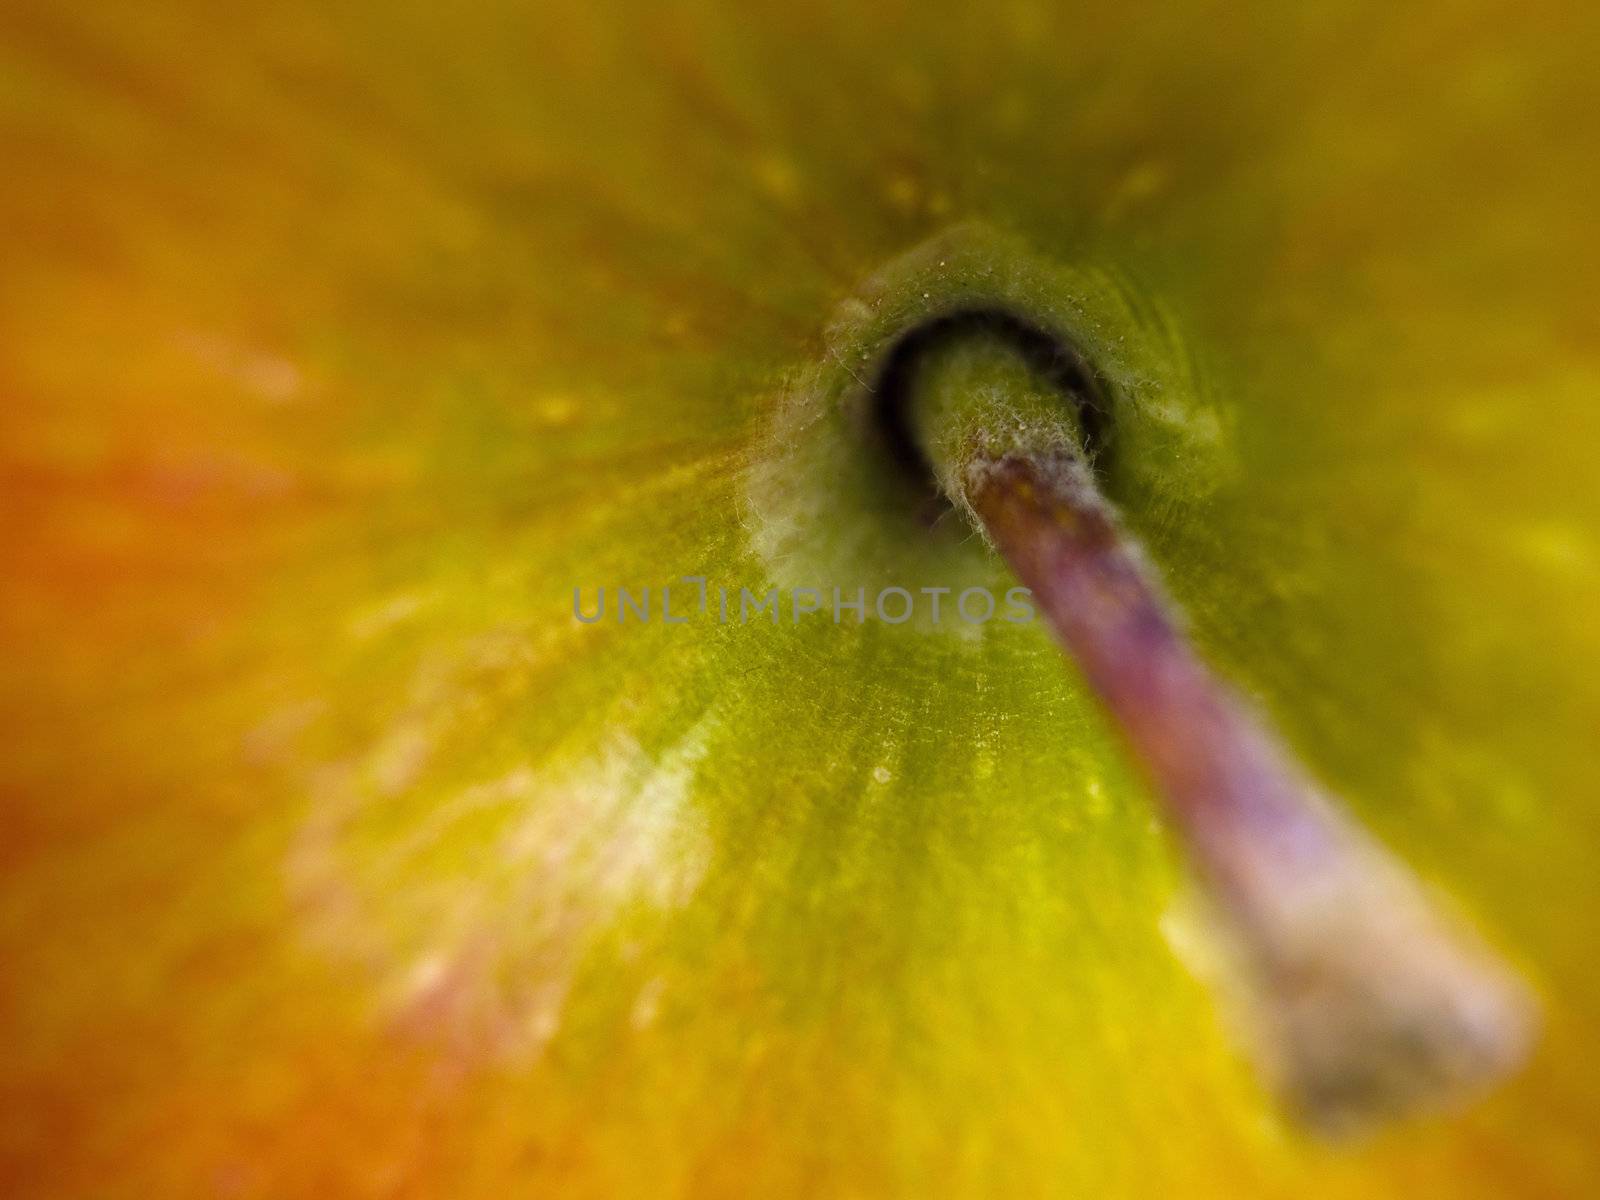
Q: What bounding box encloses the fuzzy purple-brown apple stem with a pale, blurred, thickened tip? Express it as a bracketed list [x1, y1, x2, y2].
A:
[915, 331, 1536, 1134]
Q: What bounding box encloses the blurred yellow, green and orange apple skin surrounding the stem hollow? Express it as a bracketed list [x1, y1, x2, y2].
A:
[0, 0, 1600, 1197]
